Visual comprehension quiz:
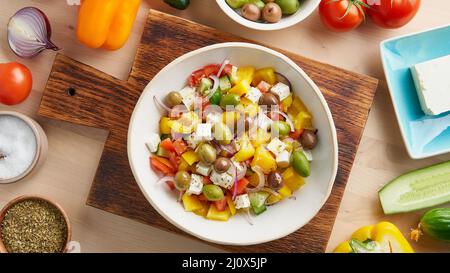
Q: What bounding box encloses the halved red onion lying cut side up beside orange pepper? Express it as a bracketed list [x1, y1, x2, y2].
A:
[8, 7, 59, 58]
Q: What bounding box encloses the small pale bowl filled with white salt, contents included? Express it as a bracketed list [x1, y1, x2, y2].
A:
[0, 111, 48, 184]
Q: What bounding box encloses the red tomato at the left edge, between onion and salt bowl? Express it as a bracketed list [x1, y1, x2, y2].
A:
[0, 63, 33, 105]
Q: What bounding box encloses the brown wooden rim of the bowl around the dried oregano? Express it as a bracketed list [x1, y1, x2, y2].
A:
[0, 195, 72, 253]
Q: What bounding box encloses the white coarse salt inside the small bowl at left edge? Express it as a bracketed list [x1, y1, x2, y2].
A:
[0, 115, 37, 182]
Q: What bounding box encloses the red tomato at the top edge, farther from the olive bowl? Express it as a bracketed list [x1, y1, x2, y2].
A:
[367, 0, 420, 28]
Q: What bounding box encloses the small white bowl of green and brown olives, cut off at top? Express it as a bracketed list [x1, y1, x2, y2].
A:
[216, 0, 320, 30]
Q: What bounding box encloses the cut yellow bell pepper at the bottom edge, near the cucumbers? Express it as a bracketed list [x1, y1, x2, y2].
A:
[334, 222, 414, 253]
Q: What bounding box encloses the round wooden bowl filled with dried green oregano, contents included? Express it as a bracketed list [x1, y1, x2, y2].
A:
[0, 195, 72, 253]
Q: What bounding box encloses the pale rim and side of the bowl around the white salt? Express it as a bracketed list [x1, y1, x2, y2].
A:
[0, 111, 48, 184]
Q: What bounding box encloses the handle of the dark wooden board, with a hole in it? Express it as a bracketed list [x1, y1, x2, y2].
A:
[39, 54, 140, 131]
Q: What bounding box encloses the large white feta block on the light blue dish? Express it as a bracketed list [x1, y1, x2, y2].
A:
[411, 55, 450, 115]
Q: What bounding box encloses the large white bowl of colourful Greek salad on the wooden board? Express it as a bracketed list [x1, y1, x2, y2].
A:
[128, 43, 338, 245]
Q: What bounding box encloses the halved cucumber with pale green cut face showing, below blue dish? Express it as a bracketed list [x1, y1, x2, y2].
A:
[378, 161, 450, 214]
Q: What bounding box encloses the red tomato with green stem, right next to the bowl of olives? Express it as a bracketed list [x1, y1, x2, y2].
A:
[319, 0, 366, 32]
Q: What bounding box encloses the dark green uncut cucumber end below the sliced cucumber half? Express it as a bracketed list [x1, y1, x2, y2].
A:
[419, 208, 450, 242]
